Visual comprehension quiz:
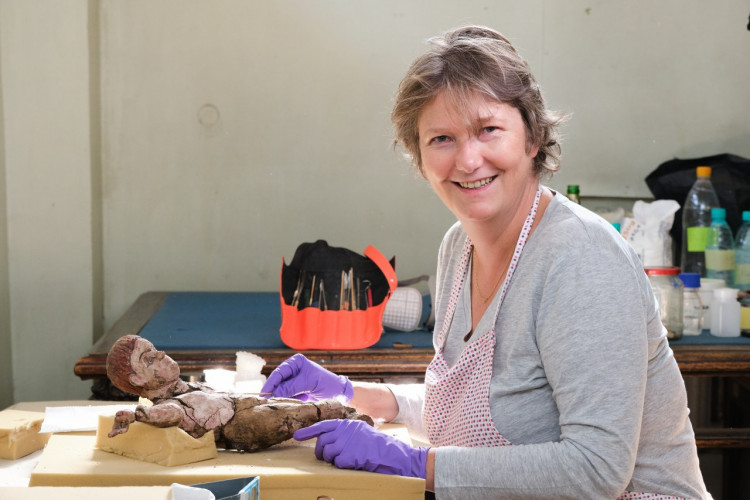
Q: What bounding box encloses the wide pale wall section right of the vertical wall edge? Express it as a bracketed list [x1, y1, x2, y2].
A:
[102, 0, 750, 332]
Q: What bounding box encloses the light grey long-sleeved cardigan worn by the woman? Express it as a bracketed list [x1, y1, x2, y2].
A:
[389, 193, 710, 500]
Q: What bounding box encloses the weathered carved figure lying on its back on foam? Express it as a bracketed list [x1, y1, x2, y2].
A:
[107, 335, 373, 452]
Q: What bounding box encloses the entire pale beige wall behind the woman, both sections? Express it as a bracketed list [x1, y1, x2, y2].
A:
[0, 0, 750, 404]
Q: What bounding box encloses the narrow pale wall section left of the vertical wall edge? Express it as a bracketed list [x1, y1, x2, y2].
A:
[0, 0, 95, 401]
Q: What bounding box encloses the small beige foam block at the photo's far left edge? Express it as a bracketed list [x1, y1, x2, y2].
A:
[0, 409, 50, 460]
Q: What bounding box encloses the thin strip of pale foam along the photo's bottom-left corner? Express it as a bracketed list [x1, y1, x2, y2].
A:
[0, 486, 172, 500]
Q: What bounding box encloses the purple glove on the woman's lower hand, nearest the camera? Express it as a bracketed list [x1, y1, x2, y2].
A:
[294, 420, 429, 479]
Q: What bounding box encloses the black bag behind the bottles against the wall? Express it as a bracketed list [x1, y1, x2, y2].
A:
[646, 154, 750, 264]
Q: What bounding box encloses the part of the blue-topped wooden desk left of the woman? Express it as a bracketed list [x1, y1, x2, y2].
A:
[74, 292, 434, 390]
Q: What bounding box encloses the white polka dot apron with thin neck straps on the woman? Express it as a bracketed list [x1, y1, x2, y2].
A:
[423, 185, 681, 500]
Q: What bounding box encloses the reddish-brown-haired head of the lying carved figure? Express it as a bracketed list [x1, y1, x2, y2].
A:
[107, 335, 180, 397]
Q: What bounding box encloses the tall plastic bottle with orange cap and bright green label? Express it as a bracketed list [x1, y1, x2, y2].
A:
[680, 167, 719, 277]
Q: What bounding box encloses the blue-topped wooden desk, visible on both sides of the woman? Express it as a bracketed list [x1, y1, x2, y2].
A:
[74, 292, 750, 448]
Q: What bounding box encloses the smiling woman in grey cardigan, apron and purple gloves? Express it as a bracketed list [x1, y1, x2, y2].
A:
[263, 26, 710, 499]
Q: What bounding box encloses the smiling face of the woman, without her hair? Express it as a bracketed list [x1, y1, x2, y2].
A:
[418, 92, 539, 222]
